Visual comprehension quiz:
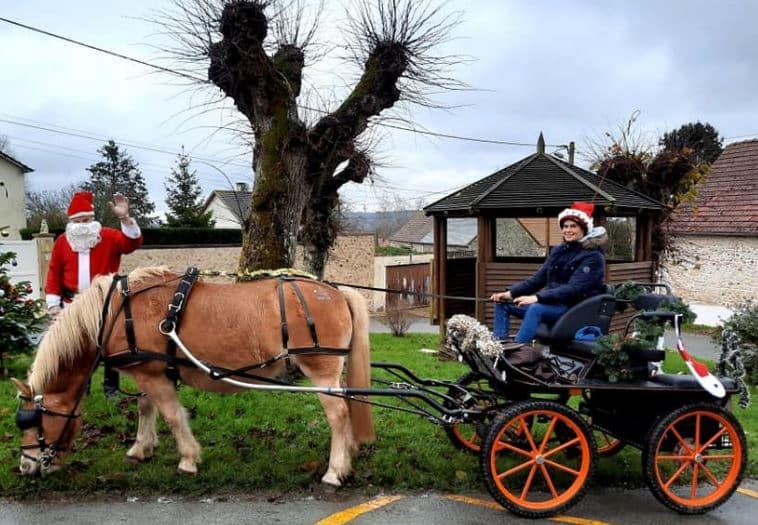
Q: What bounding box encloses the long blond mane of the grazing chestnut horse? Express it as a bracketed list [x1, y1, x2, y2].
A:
[29, 266, 173, 392]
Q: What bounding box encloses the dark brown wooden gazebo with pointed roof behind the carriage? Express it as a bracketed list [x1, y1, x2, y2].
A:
[424, 135, 663, 329]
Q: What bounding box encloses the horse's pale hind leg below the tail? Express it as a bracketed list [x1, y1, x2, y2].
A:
[299, 356, 357, 487]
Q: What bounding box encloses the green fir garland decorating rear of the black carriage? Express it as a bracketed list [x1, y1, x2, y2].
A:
[597, 281, 695, 383]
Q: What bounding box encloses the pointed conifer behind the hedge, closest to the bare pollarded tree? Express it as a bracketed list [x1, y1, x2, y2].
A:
[165, 152, 213, 228]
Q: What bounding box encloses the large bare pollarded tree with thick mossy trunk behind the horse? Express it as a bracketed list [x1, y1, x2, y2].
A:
[158, 0, 464, 276]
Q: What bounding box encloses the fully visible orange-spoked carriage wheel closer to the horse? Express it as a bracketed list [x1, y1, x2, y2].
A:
[480, 400, 595, 518]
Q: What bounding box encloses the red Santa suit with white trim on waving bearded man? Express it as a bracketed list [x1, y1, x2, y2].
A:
[45, 194, 142, 308]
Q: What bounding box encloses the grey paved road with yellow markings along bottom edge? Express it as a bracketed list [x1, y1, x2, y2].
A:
[0, 482, 758, 525]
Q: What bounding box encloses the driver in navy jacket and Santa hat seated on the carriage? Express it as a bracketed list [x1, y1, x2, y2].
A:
[491, 202, 608, 343]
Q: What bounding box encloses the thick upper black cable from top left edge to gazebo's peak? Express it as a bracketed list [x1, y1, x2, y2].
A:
[0, 17, 564, 147]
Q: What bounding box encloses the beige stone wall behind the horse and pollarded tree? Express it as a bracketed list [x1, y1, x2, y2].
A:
[121, 235, 374, 299]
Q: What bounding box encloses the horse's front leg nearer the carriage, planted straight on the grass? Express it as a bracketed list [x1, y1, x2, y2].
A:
[135, 376, 200, 474]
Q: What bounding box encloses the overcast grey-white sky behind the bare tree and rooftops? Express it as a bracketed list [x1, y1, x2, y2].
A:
[0, 0, 758, 217]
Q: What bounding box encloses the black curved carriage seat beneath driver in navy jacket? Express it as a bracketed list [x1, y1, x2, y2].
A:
[537, 294, 616, 344]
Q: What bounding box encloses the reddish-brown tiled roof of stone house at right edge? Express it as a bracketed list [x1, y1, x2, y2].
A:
[671, 140, 758, 235]
